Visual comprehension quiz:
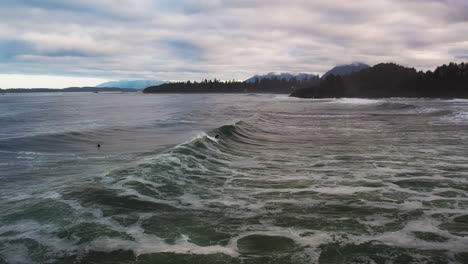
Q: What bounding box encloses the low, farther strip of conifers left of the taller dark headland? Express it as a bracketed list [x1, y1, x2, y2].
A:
[143, 78, 319, 94]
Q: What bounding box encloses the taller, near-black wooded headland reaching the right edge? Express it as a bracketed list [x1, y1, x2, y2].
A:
[291, 63, 468, 98]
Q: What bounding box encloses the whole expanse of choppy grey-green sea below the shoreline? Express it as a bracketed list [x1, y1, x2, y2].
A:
[0, 94, 468, 263]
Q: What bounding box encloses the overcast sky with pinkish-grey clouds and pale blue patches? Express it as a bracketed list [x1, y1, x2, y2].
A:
[0, 0, 468, 88]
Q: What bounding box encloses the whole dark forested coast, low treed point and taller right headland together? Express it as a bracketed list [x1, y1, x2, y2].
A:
[143, 63, 468, 98]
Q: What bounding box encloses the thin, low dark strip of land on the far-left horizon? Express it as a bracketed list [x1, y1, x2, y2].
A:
[0, 87, 138, 93]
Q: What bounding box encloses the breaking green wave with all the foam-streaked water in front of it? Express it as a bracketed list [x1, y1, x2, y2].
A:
[0, 96, 468, 263]
